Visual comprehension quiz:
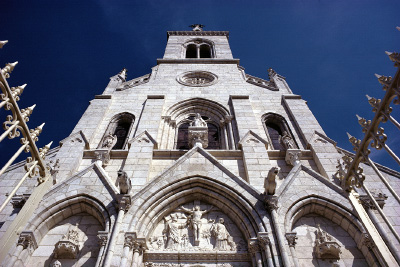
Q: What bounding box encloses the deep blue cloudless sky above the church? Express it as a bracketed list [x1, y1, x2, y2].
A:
[0, 0, 400, 170]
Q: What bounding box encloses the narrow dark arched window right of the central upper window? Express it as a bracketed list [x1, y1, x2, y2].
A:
[263, 113, 297, 150]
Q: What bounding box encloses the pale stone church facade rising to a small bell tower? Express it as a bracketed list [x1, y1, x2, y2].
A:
[0, 25, 400, 267]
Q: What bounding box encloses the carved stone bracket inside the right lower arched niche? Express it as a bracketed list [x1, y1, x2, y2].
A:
[314, 224, 342, 259]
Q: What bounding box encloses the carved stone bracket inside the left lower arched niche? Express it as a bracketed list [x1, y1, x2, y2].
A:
[54, 225, 79, 259]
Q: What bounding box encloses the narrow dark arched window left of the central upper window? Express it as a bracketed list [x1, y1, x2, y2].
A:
[99, 113, 135, 149]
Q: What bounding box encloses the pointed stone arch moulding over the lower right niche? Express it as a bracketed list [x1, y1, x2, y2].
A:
[284, 196, 378, 266]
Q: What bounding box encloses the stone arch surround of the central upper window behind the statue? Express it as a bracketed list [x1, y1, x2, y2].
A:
[160, 98, 235, 149]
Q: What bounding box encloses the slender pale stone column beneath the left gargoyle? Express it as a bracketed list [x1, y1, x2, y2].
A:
[103, 195, 131, 267]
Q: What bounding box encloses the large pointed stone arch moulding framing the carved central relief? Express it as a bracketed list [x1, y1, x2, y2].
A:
[129, 176, 269, 239]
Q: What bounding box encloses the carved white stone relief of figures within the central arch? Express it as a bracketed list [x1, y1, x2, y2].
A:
[148, 201, 247, 253]
